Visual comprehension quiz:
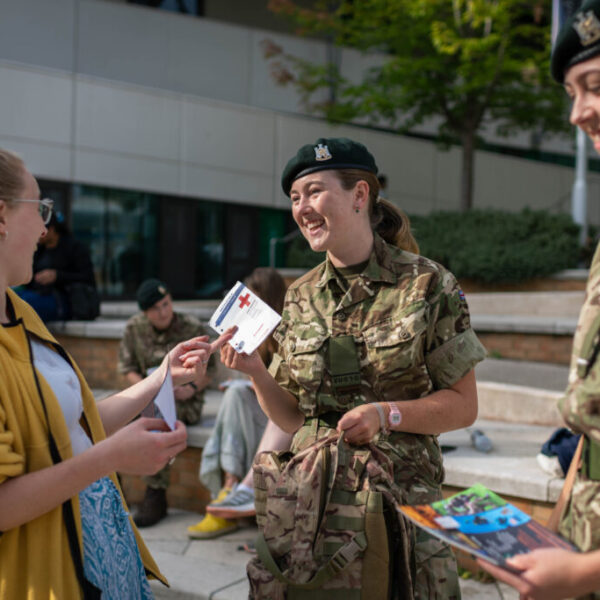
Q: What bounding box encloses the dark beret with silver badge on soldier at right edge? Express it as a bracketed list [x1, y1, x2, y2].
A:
[551, 0, 600, 83]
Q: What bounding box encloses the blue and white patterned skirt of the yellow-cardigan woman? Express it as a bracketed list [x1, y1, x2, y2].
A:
[79, 477, 154, 600]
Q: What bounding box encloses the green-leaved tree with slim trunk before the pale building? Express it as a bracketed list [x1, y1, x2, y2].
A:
[264, 0, 567, 210]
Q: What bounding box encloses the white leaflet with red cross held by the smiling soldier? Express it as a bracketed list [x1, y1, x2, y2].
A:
[208, 281, 281, 354]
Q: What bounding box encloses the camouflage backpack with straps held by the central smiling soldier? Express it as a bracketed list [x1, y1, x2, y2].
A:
[247, 432, 414, 600]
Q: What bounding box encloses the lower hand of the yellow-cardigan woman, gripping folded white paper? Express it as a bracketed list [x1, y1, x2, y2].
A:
[100, 417, 187, 475]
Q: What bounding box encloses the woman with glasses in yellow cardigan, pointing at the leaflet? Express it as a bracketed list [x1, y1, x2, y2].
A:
[0, 150, 230, 600]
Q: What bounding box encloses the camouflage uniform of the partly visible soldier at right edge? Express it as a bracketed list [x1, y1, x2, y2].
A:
[559, 245, 600, 600]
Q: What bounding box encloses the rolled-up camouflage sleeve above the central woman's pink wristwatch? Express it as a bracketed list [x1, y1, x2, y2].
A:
[425, 270, 486, 389]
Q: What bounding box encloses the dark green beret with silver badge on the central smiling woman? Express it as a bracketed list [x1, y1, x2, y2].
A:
[281, 138, 377, 196]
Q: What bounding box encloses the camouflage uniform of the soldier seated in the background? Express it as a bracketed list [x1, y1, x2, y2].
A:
[118, 312, 214, 488]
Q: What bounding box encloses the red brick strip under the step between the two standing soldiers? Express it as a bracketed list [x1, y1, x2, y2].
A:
[477, 331, 573, 365]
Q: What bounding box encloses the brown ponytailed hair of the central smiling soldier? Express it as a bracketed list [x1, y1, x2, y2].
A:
[334, 169, 419, 254]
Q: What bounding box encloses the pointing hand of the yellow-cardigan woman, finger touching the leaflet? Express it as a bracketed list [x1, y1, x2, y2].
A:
[169, 327, 236, 385]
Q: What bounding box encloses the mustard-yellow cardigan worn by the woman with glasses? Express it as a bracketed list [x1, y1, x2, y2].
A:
[0, 290, 167, 600]
